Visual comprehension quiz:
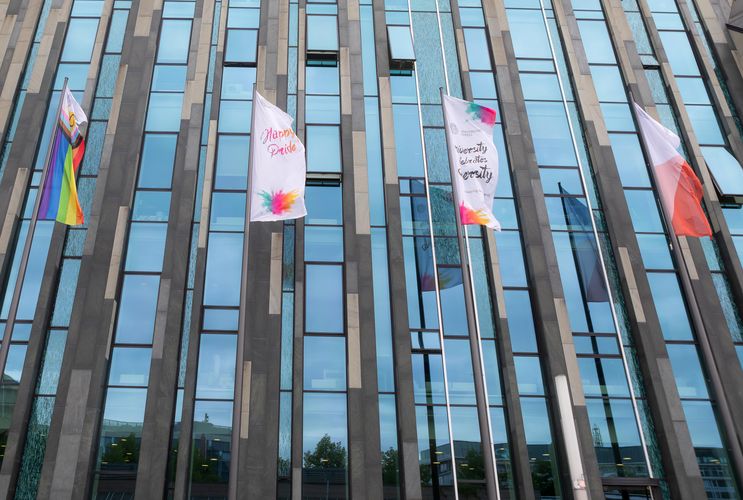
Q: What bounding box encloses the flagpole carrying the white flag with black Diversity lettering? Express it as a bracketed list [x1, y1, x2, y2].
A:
[442, 88, 500, 499]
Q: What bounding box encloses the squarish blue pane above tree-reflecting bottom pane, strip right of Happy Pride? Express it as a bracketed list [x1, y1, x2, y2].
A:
[304, 336, 346, 391]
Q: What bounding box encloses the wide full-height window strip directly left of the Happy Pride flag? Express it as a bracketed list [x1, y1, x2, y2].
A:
[189, 2, 260, 497]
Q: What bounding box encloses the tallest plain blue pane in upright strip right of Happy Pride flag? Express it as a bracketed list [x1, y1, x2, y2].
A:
[305, 265, 345, 333]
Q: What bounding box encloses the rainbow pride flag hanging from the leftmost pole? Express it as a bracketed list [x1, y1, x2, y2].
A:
[39, 88, 88, 226]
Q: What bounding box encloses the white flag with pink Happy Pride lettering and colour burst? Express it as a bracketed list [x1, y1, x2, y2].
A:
[250, 92, 307, 221]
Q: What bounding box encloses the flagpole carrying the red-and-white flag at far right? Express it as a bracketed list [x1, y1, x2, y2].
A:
[627, 92, 743, 478]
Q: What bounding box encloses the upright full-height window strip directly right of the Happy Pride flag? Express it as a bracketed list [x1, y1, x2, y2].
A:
[302, 1, 350, 498]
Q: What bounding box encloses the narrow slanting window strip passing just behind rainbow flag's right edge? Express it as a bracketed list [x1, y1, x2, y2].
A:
[16, 1, 131, 498]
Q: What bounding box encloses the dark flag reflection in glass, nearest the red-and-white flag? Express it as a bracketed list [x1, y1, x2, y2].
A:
[560, 185, 609, 302]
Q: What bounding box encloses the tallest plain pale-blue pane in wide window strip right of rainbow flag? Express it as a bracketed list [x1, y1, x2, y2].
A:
[116, 274, 160, 344]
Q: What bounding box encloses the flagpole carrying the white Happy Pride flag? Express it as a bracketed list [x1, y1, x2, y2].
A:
[227, 83, 258, 498]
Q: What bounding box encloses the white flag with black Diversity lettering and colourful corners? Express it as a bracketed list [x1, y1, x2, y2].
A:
[443, 95, 500, 231]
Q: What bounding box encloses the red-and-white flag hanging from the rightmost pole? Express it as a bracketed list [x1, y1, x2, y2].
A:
[633, 103, 712, 237]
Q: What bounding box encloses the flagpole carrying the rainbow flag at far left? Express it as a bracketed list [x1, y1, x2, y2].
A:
[0, 77, 68, 376]
